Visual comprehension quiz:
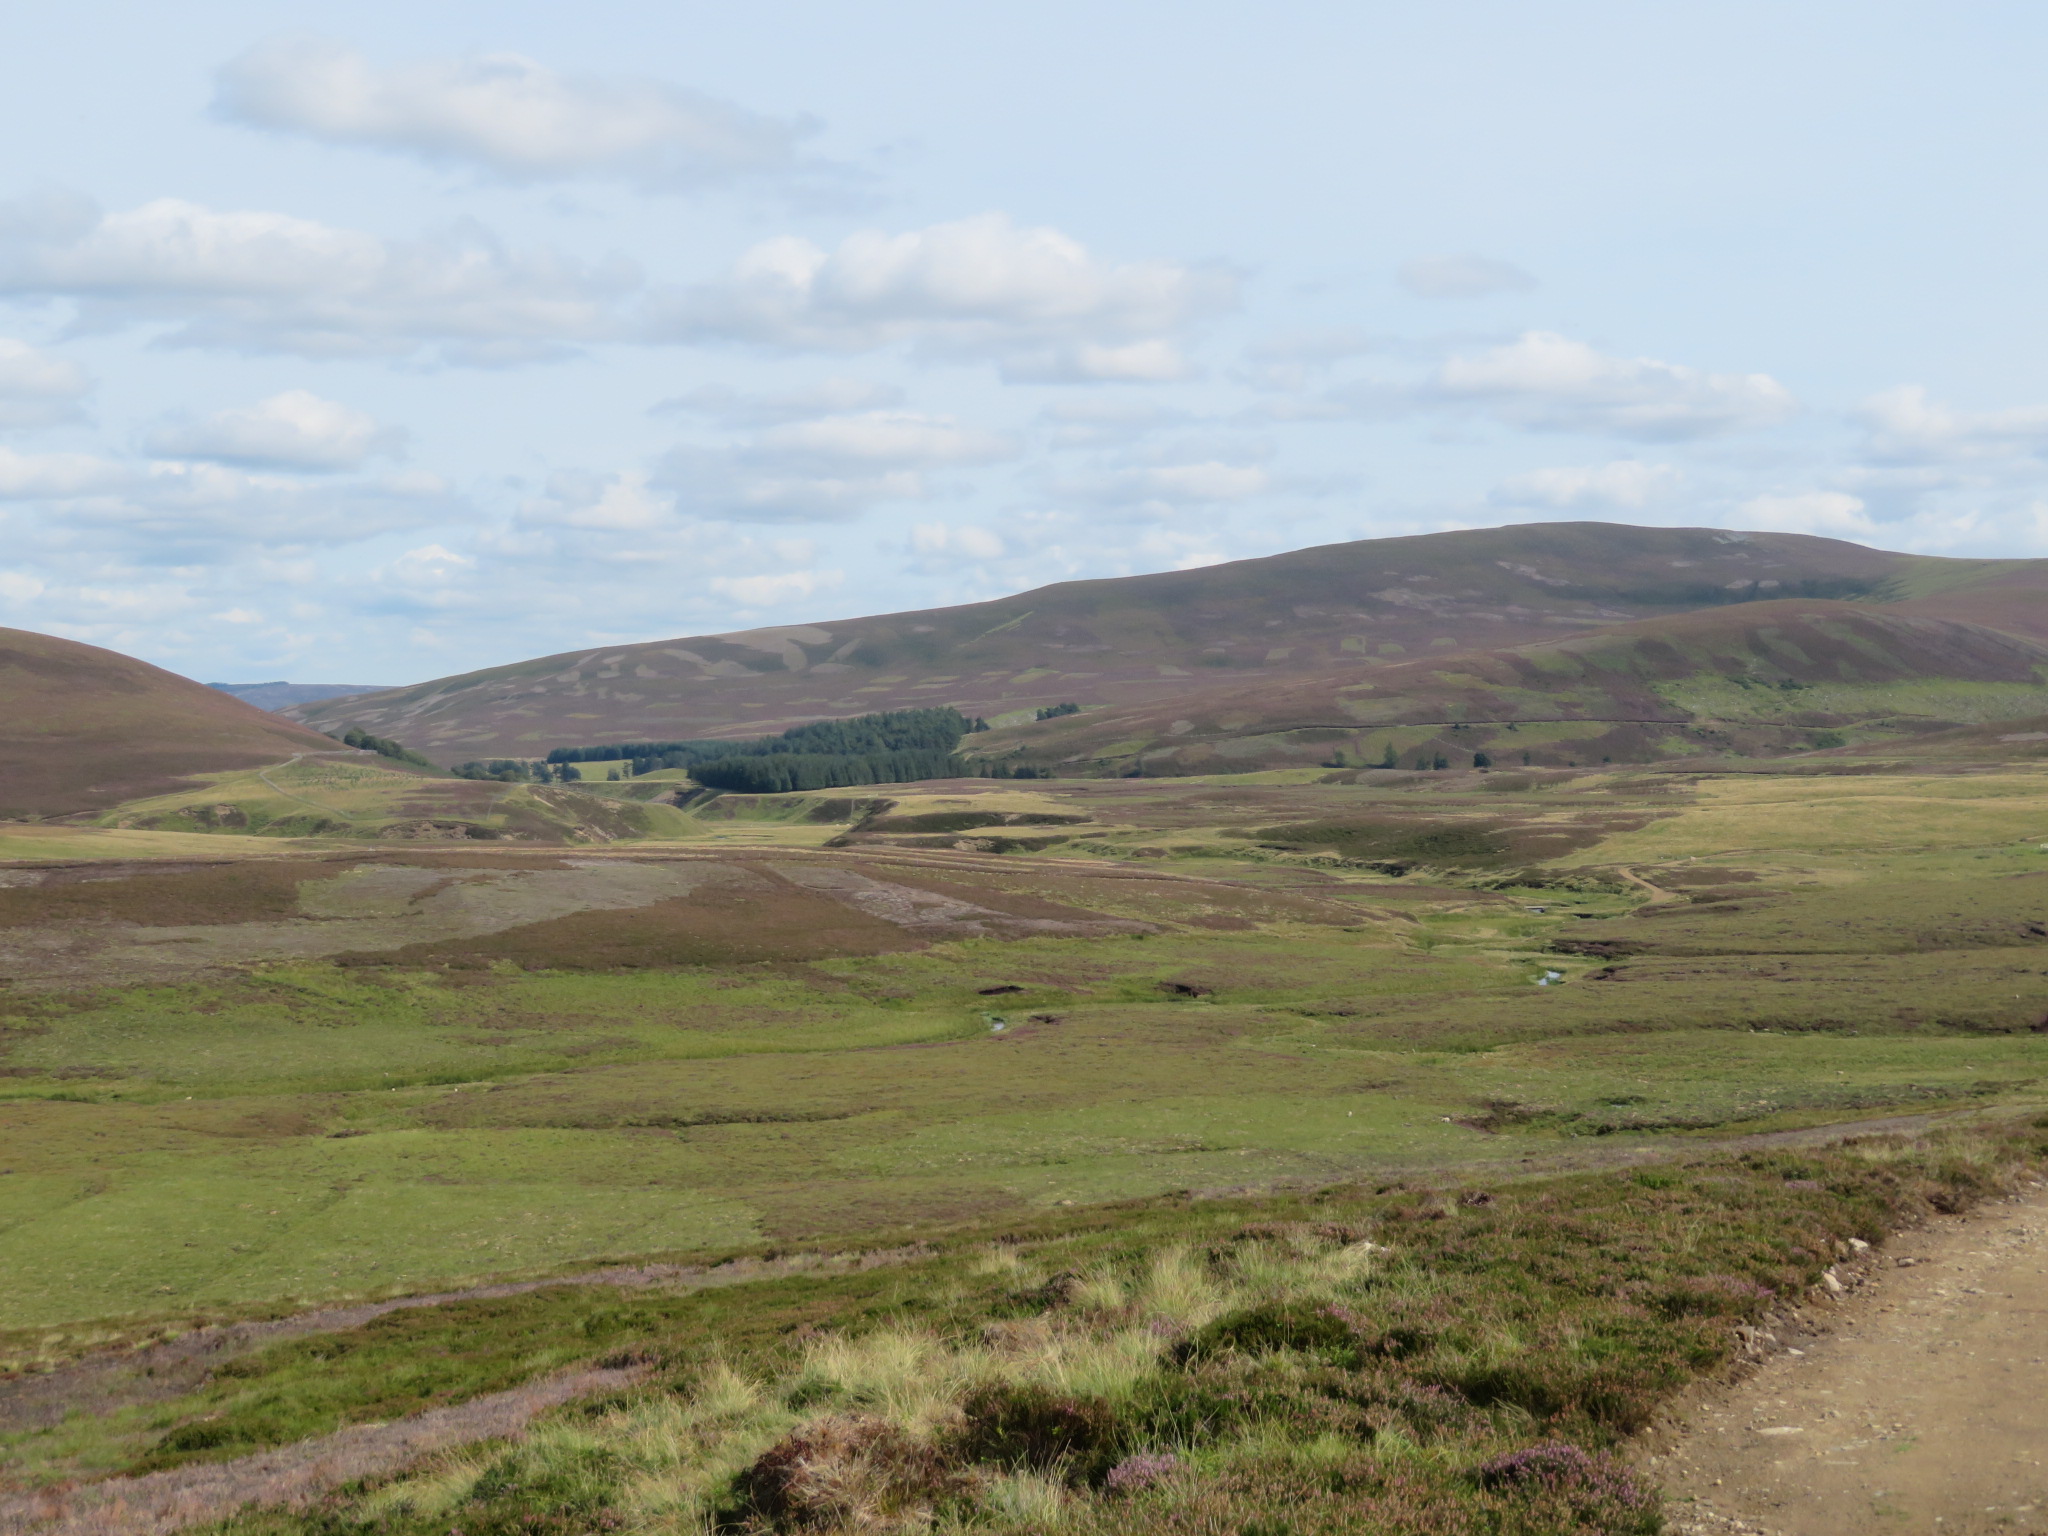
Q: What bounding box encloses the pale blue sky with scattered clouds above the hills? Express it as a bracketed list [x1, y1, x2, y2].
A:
[0, 0, 2048, 684]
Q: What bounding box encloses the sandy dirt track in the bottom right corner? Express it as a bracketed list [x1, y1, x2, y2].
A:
[1645, 1184, 2048, 1536]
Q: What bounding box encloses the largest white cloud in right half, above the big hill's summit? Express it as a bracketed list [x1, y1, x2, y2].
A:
[1430, 330, 1796, 440]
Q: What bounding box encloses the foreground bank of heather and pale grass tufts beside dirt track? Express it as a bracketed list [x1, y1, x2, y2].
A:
[203, 1128, 2048, 1536]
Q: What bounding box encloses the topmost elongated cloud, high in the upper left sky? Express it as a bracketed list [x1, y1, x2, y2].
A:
[215, 37, 813, 190]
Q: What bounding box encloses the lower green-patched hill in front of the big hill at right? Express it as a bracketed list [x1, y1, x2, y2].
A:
[973, 600, 2048, 774]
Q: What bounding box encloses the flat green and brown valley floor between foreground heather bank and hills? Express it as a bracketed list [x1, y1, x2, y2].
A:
[0, 764, 2048, 1360]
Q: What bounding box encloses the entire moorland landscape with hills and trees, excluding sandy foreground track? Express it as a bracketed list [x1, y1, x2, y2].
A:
[0, 524, 2048, 1536]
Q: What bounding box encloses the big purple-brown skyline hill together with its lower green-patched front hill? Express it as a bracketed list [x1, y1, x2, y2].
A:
[289, 522, 2048, 772]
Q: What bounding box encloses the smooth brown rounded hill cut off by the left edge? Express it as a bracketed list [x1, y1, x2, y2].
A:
[0, 629, 336, 819]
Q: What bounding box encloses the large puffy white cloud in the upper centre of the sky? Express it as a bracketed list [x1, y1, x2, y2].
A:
[657, 213, 1237, 367]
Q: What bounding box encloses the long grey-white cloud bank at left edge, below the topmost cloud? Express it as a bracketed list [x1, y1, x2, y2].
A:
[0, 197, 639, 365]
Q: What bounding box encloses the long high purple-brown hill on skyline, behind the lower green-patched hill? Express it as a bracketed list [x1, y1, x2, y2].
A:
[287, 522, 1949, 764]
